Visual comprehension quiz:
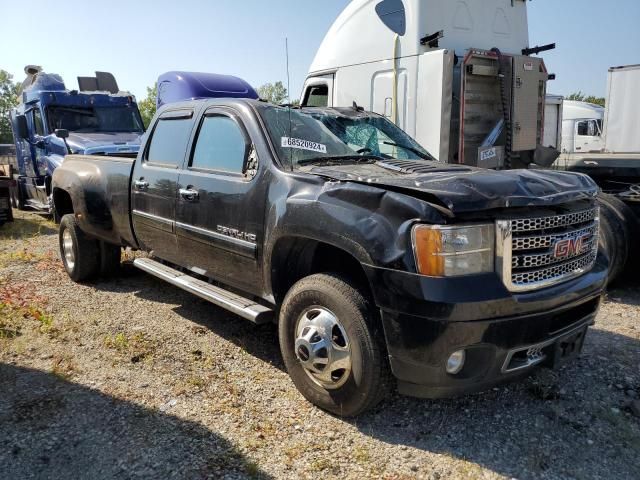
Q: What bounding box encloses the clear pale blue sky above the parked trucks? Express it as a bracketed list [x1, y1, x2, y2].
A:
[0, 0, 640, 98]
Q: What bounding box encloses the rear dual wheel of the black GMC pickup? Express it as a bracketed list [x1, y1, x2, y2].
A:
[59, 214, 100, 282]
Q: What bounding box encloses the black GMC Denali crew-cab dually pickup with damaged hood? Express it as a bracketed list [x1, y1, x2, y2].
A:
[53, 99, 607, 416]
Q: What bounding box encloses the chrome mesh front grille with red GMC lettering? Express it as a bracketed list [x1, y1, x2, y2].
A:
[496, 207, 599, 292]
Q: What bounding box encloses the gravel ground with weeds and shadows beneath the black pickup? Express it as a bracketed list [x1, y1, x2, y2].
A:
[0, 212, 640, 479]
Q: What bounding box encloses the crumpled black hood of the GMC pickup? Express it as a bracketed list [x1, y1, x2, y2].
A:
[305, 160, 598, 213]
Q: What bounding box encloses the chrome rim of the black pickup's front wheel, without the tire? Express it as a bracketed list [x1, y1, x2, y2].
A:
[295, 307, 351, 390]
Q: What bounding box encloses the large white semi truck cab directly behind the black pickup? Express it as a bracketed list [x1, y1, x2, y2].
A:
[301, 0, 557, 168]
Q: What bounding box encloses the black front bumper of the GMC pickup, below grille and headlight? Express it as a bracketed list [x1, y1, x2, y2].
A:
[366, 256, 607, 398]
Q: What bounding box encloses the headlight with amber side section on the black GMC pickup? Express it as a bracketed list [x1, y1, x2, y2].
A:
[412, 224, 495, 277]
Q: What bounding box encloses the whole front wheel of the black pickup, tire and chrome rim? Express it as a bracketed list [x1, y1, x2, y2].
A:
[279, 274, 391, 417]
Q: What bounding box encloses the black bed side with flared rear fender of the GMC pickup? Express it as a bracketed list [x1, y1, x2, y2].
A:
[53, 155, 137, 247]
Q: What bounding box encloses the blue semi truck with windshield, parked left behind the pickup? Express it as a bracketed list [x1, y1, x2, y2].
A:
[11, 65, 144, 215]
